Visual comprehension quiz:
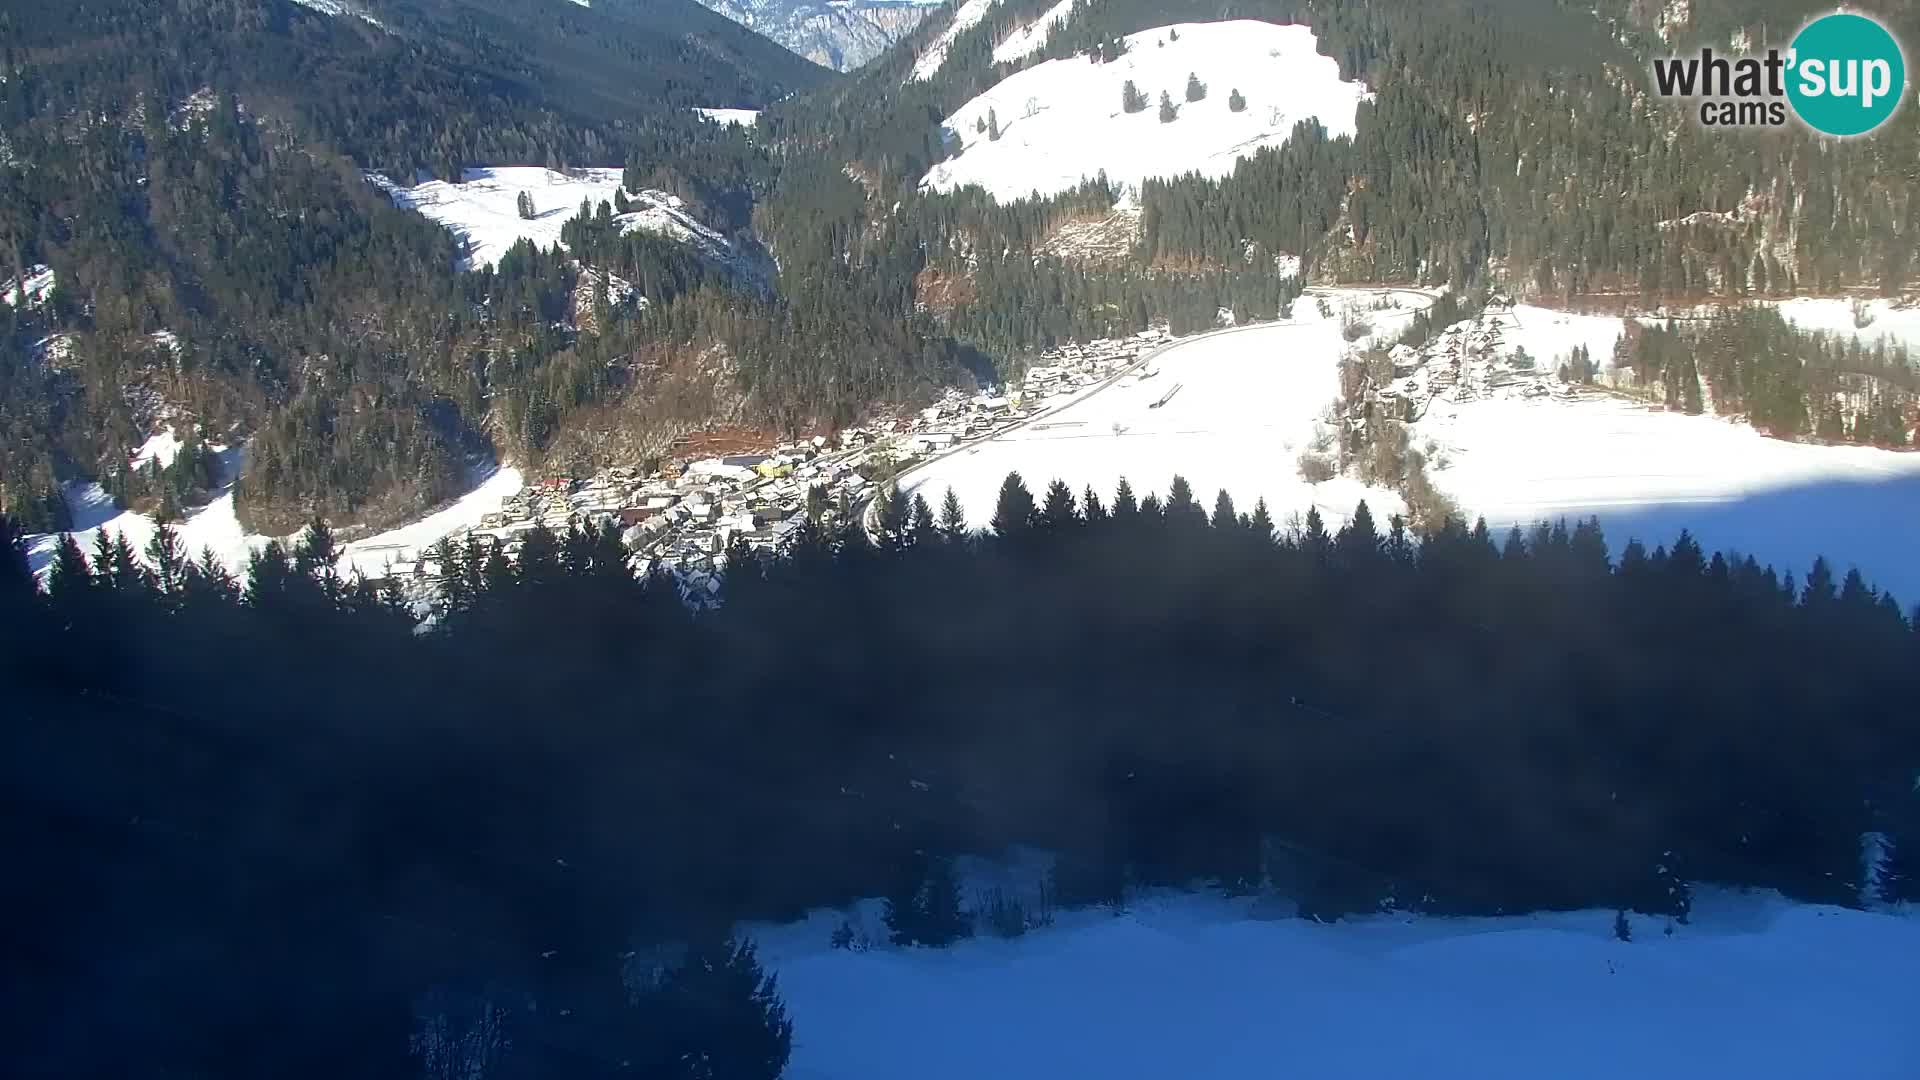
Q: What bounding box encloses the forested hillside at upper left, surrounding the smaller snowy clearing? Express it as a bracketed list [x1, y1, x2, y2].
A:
[0, 0, 828, 532]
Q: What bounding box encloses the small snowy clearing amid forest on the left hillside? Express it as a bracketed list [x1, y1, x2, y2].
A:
[367, 167, 733, 269]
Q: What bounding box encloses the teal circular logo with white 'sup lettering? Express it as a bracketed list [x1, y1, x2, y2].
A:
[1788, 12, 1907, 135]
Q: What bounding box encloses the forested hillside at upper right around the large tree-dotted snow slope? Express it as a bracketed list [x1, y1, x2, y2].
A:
[770, 0, 1920, 311]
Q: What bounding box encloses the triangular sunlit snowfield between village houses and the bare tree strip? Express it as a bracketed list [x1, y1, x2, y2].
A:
[900, 290, 1428, 528]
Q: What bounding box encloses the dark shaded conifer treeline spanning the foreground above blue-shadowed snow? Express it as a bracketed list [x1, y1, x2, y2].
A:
[0, 468, 1920, 1076]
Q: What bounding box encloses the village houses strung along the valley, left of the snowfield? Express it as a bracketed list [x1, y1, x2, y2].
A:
[360, 327, 1169, 592]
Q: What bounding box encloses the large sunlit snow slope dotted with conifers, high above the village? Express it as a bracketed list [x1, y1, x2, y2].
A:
[920, 20, 1367, 202]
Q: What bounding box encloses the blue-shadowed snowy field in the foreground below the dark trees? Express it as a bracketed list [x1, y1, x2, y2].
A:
[755, 890, 1920, 1080]
